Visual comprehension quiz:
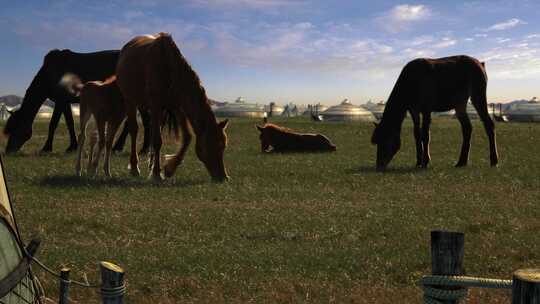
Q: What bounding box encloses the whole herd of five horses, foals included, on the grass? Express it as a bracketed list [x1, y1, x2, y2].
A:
[4, 33, 498, 181]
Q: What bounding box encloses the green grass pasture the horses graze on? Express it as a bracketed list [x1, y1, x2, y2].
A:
[1, 119, 540, 303]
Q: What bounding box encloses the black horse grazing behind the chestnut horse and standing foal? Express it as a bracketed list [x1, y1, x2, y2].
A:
[4, 50, 150, 153]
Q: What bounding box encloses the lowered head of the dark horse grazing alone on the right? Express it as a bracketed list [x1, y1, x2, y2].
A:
[371, 123, 401, 171]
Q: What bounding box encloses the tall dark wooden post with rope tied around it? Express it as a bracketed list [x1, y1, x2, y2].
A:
[431, 231, 465, 304]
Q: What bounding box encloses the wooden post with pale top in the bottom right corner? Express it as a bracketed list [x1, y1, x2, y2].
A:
[512, 269, 540, 304]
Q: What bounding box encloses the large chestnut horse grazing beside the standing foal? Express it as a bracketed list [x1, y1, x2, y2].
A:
[116, 33, 228, 181]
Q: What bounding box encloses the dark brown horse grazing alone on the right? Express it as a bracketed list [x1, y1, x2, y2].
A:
[371, 56, 498, 170]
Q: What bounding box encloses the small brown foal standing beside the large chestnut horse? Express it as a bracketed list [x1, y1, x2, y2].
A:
[63, 75, 126, 177]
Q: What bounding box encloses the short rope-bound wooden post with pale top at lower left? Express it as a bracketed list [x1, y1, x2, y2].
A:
[100, 262, 125, 304]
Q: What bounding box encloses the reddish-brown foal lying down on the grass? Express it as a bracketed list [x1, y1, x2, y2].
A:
[257, 124, 336, 152]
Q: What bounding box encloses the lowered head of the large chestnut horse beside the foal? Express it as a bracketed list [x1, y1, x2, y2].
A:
[195, 119, 229, 182]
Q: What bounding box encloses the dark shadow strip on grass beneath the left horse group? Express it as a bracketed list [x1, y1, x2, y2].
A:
[39, 175, 207, 188]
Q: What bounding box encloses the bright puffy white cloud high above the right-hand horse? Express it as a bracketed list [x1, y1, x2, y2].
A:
[376, 4, 432, 33]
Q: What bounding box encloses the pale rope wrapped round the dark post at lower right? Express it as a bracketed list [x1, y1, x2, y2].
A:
[420, 275, 512, 304]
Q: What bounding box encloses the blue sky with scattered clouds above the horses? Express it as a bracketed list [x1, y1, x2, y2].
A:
[0, 0, 540, 104]
